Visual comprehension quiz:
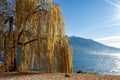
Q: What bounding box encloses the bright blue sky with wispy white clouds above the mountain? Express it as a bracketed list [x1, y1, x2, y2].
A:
[53, 0, 120, 48]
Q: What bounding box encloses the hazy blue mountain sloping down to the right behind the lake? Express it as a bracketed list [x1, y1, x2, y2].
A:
[68, 36, 120, 53]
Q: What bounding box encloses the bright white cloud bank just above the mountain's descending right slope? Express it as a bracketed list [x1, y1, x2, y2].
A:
[95, 36, 120, 48]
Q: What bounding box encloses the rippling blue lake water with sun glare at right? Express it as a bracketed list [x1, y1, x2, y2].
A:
[73, 53, 120, 75]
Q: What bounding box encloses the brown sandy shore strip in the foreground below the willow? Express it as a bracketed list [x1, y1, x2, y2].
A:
[0, 72, 120, 80]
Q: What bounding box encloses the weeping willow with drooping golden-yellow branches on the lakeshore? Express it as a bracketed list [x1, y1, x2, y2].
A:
[0, 0, 72, 72]
